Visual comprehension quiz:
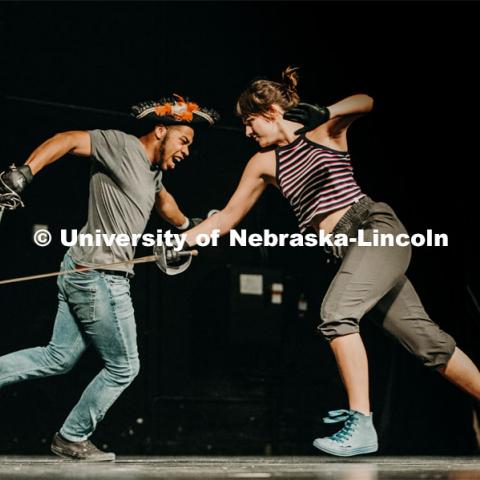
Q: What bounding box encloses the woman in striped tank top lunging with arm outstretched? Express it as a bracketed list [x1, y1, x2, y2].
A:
[181, 68, 480, 456]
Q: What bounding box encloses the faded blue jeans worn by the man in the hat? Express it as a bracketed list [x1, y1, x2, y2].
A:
[0, 252, 140, 442]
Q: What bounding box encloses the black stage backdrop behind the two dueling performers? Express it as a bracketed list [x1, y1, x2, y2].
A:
[0, 2, 480, 454]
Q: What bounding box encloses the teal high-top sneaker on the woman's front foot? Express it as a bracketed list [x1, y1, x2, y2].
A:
[313, 410, 378, 457]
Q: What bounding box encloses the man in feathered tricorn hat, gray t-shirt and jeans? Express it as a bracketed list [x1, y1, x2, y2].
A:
[0, 96, 218, 461]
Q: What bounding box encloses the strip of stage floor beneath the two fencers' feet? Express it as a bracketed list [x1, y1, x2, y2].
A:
[0, 455, 480, 480]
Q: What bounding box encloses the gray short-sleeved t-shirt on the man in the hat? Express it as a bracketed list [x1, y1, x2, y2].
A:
[70, 130, 162, 273]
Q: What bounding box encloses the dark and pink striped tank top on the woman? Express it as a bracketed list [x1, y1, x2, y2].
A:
[275, 135, 365, 233]
